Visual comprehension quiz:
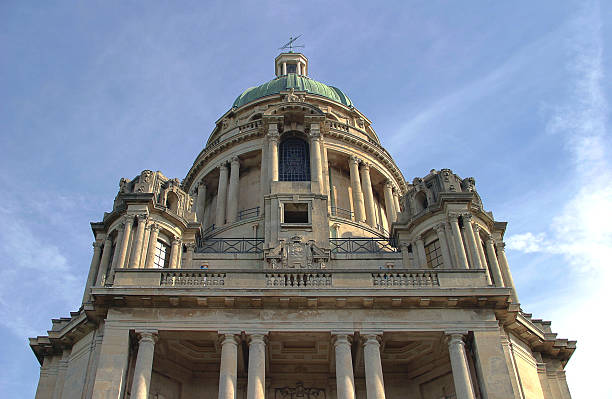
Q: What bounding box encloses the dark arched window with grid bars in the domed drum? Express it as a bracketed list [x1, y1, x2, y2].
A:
[278, 137, 310, 181]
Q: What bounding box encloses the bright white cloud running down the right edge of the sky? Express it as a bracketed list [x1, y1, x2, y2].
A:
[507, 2, 612, 397]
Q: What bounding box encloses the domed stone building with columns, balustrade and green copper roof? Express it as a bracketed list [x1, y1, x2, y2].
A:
[30, 52, 575, 399]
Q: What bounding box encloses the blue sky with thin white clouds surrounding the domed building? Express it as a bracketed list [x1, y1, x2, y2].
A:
[0, 0, 612, 398]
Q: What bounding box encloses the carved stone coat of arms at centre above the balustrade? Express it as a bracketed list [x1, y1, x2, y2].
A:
[266, 235, 329, 269]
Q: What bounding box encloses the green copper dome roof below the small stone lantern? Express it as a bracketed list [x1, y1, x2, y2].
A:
[232, 73, 353, 108]
